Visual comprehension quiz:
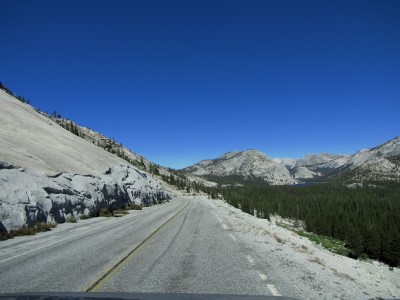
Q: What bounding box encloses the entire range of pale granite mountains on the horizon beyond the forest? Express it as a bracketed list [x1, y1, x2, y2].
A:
[183, 137, 400, 185]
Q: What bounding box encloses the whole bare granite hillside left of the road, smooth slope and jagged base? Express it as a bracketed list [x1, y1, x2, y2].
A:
[0, 90, 168, 231]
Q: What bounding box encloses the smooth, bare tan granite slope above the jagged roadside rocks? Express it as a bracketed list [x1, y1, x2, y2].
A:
[0, 91, 127, 175]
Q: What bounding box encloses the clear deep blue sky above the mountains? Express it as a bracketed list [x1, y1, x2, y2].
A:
[0, 0, 400, 168]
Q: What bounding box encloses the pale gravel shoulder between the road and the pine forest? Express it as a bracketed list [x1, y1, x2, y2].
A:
[208, 196, 400, 299]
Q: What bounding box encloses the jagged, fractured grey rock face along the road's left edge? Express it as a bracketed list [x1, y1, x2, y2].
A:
[0, 162, 168, 232]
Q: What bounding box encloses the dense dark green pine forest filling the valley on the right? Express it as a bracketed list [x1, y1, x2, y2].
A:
[208, 182, 400, 266]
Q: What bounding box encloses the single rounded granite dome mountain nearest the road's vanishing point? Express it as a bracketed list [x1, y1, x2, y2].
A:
[183, 150, 297, 185]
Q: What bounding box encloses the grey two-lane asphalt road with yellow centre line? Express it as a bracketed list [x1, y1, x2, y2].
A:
[0, 197, 283, 295]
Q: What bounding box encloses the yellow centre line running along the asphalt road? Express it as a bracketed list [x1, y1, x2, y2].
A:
[83, 201, 191, 292]
